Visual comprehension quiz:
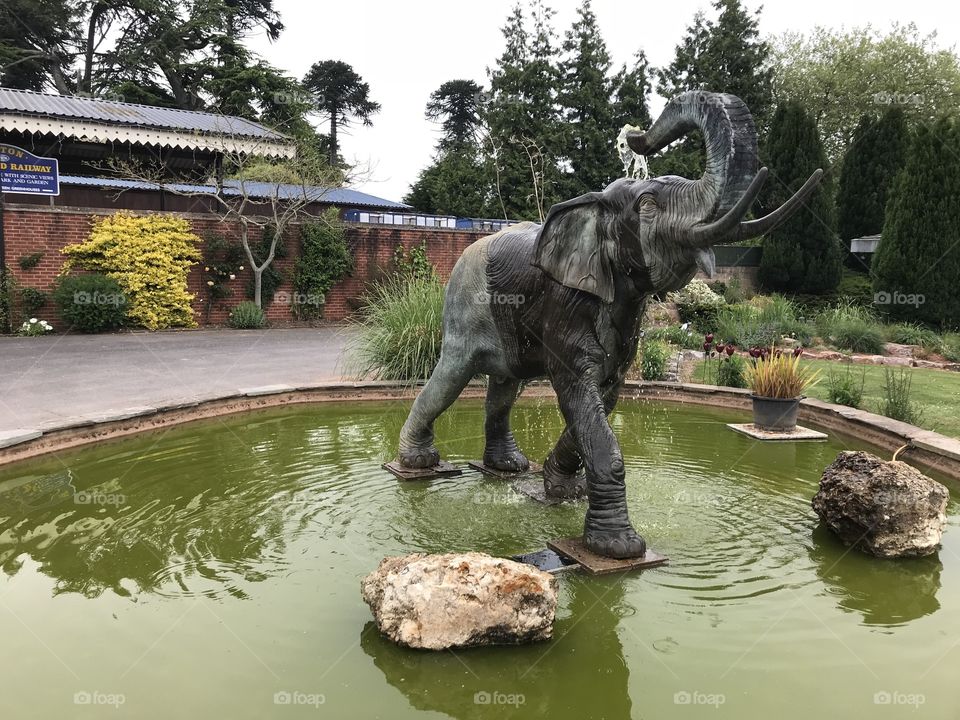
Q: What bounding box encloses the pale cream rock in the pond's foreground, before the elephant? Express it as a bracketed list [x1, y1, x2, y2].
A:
[361, 553, 557, 650]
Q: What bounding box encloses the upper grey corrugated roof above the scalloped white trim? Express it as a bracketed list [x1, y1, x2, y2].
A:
[0, 87, 288, 141]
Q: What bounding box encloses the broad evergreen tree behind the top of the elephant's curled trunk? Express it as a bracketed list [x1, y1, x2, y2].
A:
[651, 0, 773, 177]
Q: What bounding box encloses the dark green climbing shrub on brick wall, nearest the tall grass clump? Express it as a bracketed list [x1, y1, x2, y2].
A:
[291, 214, 353, 318]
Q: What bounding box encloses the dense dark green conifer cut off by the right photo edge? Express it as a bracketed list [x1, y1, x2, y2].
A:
[872, 117, 960, 328]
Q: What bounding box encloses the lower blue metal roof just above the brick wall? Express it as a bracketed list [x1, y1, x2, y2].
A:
[60, 175, 412, 210]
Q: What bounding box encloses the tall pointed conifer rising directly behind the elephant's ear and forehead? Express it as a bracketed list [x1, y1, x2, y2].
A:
[558, 0, 620, 197]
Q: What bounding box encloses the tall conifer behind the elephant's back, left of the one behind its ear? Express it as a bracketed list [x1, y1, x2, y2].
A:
[484, 0, 560, 220]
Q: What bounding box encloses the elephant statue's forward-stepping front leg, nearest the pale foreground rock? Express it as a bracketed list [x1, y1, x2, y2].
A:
[551, 369, 647, 558]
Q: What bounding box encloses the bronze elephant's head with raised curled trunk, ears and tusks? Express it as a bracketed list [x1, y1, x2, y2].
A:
[534, 91, 823, 303]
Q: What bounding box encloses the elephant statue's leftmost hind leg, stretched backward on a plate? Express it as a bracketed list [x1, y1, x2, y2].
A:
[399, 352, 474, 468]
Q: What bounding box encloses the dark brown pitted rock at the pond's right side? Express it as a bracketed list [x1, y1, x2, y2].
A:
[813, 451, 950, 558]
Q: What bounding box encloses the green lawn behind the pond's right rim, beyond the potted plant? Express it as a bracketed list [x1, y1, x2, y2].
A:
[690, 360, 960, 438]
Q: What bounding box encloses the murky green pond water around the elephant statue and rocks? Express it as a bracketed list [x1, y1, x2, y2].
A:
[0, 400, 960, 720]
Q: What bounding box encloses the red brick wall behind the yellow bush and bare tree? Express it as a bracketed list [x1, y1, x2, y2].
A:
[3, 204, 486, 327]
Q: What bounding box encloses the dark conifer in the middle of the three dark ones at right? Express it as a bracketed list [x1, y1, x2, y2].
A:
[837, 107, 910, 242]
